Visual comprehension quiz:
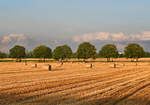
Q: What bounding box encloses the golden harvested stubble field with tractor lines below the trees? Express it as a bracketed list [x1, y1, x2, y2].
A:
[0, 59, 150, 105]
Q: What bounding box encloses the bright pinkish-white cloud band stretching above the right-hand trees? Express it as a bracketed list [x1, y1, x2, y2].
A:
[72, 31, 150, 42]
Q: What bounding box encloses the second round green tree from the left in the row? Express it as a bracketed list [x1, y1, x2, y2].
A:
[32, 45, 52, 62]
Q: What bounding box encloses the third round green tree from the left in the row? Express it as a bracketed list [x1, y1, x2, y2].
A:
[53, 45, 72, 60]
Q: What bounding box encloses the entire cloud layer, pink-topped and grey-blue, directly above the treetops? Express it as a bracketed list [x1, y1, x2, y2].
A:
[0, 31, 150, 52]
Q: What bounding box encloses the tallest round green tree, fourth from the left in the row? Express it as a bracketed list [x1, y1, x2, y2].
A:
[76, 42, 96, 60]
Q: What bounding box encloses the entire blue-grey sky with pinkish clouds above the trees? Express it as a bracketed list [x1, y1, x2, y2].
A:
[0, 0, 150, 52]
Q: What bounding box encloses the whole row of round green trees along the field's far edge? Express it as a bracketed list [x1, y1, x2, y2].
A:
[0, 42, 146, 61]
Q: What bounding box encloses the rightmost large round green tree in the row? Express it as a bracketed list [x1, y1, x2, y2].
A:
[124, 43, 145, 61]
